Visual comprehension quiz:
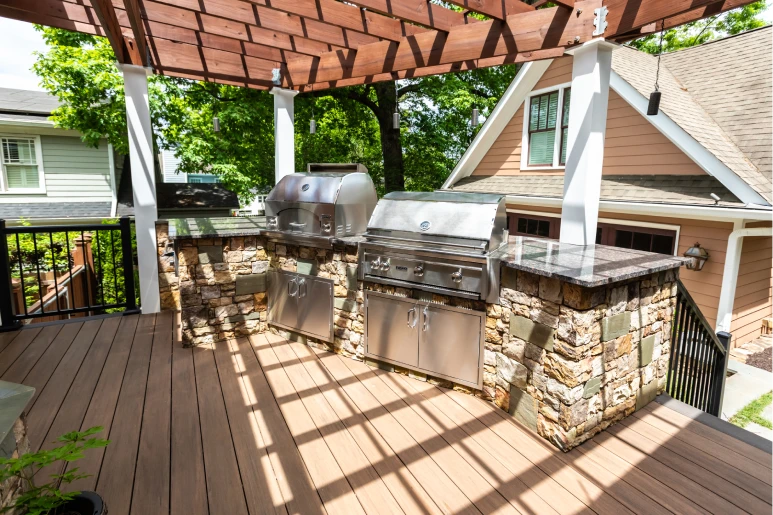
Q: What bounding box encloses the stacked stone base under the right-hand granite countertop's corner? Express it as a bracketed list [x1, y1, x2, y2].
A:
[482, 269, 677, 450]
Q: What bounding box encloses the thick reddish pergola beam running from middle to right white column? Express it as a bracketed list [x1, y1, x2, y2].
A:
[283, 0, 601, 87]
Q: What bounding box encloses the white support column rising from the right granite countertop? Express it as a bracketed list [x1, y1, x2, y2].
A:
[561, 39, 614, 245]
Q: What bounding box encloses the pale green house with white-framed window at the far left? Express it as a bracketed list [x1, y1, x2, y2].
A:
[0, 88, 123, 219]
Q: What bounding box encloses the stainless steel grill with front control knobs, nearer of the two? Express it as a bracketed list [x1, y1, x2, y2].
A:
[359, 192, 507, 303]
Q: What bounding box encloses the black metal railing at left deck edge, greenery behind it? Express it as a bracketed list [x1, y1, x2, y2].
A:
[0, 217, 137, 330]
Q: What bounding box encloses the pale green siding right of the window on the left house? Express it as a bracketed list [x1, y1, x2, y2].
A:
[0, 136, 112, 203]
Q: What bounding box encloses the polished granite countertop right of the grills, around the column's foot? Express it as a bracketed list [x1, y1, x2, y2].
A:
[498, 236, 688, 288]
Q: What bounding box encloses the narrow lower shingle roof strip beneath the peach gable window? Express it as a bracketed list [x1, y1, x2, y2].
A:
[452, 175, 744, 207]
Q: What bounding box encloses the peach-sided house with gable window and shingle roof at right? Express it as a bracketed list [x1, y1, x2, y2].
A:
[444, 27, 773, 345]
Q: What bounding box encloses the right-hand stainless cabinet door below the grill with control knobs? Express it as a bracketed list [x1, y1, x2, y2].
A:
[419, 305, 482, 384]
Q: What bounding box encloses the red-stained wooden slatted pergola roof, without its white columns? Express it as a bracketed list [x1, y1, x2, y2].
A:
[0, 0, 752, 91]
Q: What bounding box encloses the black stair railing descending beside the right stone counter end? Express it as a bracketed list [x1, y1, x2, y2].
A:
[666, 281, 730, 417]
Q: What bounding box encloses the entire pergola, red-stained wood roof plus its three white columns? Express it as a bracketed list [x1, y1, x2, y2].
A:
[0, 0, 754, 313]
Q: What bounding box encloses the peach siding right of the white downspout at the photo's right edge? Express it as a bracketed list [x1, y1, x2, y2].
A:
[730, 222, 773, 346]
